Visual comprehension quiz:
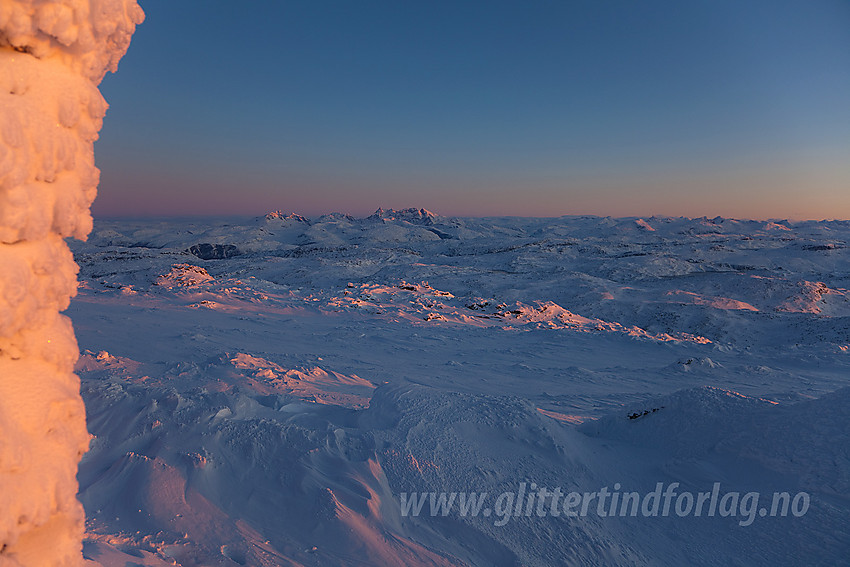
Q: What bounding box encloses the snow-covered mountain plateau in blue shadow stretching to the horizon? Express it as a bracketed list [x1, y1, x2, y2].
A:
[66, 209, 850, 566]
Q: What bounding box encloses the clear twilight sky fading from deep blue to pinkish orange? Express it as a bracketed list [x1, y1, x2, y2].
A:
[93, 0, 850, 219]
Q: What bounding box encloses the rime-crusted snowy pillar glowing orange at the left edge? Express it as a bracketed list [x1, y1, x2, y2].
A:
[0, 0, 144, 565]
